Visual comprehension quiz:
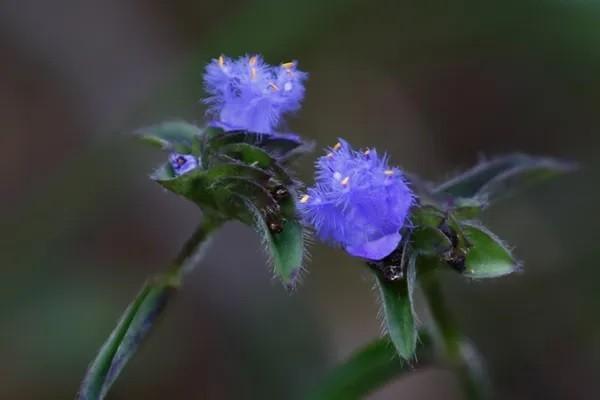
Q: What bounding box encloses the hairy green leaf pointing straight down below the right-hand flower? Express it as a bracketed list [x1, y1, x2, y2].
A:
[375, 253, 417, 361]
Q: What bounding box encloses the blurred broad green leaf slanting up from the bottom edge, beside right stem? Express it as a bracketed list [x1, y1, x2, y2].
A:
[305, 333, 433, 400]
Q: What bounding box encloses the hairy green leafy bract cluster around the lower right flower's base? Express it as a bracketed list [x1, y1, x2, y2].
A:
[368, 154, 574, 360]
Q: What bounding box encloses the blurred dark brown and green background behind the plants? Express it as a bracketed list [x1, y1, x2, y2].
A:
[0, 0, 600, 400]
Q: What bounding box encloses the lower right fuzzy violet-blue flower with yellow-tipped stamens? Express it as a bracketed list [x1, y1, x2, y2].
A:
[299, 140, 414, 260]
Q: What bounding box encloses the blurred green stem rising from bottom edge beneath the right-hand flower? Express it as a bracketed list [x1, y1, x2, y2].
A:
[421, 271, 489, 400]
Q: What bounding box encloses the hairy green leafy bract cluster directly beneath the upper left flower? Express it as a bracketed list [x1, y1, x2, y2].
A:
[140, 122, 307, 286]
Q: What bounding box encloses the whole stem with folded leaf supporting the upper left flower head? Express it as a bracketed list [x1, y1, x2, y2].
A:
[76, 216, 222, 400]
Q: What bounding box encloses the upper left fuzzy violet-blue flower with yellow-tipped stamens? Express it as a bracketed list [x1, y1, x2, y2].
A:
[204, 56, 307, 134]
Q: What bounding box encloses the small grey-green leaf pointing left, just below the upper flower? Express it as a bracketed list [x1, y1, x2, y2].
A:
[138, 121, 203, 154]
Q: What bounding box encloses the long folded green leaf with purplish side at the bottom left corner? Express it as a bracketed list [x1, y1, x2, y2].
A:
[77, 276, 176, 400]
